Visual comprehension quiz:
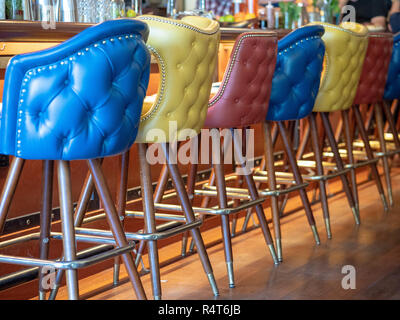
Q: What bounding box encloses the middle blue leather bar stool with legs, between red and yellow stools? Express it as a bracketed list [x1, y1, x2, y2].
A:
[247, 26, 325, 261]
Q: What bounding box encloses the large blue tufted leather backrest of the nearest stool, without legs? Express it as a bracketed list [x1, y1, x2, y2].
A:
[0, 19, 150, 160]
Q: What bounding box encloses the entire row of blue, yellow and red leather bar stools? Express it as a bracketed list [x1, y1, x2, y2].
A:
[0, 15, 400, 299]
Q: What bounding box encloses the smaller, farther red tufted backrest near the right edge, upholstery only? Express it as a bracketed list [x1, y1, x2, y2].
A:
[354, 32, 393, 104]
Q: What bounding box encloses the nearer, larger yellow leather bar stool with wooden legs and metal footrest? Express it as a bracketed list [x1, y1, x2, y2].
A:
[63, 15, 220, 299]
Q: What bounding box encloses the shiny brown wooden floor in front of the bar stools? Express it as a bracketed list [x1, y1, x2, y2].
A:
[45, 169, 400, 300]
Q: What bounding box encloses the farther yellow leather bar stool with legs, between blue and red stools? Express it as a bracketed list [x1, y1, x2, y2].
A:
[298, 22, 368, 238]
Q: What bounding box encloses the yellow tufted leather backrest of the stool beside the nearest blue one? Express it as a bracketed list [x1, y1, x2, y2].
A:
[136, 15, 220, 142]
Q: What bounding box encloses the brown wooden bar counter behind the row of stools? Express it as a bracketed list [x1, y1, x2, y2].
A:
[0, 20, 289, 299]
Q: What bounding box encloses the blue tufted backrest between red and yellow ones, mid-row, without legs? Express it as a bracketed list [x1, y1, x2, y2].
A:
[267, 26, 325, 121]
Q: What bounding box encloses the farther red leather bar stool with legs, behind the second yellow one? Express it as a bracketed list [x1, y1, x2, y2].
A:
[339, 32, 400, 209]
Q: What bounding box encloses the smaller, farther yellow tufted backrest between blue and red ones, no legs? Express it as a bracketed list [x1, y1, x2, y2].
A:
[310, 22, 368, 112]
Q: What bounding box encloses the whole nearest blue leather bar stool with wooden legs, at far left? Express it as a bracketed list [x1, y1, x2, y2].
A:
[0, 19, 150, 299]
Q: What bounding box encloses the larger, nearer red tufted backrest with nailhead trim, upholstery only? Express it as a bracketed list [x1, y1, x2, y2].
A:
[205, 32, 277, 128]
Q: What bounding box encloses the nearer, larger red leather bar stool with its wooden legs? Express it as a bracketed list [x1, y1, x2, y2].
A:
[199, 33, 278, 287]
